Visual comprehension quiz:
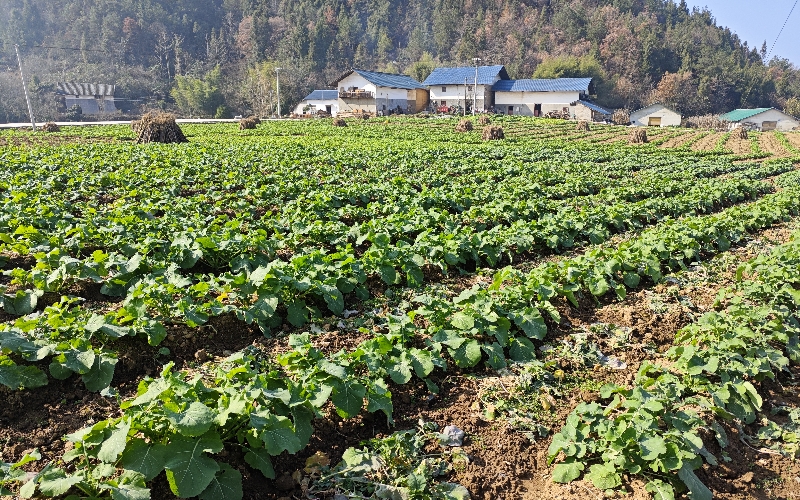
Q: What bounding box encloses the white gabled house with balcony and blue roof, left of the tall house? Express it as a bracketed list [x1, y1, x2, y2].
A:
[335, 69, 428, 115]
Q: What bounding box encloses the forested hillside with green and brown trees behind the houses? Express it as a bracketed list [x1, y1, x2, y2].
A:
[0, 0, 800, 121]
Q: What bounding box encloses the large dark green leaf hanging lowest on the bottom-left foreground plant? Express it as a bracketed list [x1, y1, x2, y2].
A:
[164, 435, 222, 498]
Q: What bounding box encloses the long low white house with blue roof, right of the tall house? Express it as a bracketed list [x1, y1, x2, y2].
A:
[493, 78, 594, 118]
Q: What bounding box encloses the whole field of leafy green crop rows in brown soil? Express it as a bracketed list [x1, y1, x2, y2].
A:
[0, 117, 800, 500]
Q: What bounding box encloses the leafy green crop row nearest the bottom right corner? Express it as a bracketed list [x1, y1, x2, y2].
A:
[548, 229, 800, 500]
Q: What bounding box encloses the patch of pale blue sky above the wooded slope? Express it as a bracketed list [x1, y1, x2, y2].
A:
[687, 0, 800, 66]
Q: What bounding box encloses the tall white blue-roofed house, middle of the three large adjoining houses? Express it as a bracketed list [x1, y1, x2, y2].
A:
[422, 66, 508, 111]
